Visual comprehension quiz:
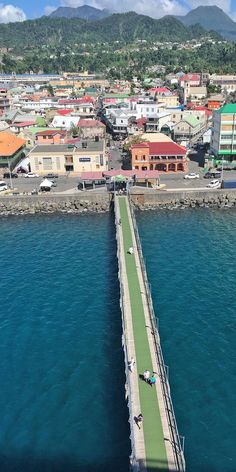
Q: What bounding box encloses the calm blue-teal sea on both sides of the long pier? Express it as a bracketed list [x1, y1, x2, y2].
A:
[0, 209, 236, 472]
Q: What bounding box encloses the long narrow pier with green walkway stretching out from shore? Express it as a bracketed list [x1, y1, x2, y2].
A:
[114, 195, 185, 472]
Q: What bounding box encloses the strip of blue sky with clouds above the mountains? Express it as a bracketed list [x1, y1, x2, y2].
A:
[0, 0, 236, 23]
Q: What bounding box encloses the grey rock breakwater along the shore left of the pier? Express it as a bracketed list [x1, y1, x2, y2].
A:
[0, 192, 110, 216]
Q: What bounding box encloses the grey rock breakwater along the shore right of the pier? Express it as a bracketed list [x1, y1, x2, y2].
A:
[131, 189, 236, 210]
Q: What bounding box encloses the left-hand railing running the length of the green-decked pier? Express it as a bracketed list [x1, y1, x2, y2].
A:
[114, 195, 140, 472]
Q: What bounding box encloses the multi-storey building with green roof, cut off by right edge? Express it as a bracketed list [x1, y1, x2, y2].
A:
[211, 103, 236, 161]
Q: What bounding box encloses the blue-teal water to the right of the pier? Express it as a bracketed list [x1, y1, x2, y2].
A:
[137, 209, 236, 472]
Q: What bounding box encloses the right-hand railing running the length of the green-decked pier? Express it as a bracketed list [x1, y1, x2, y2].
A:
[128, 196, 185, 472]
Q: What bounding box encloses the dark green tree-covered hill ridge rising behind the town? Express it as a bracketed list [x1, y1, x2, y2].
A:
[0, 12, 214, 51]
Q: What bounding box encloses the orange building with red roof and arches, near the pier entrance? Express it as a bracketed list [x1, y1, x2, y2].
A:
[131, 141, 187, 172]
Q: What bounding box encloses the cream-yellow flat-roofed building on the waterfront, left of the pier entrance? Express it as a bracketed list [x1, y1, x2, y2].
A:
[28, 139, 108, 175]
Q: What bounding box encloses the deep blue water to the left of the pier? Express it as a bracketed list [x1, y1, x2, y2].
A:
[0, 215, 130, 472]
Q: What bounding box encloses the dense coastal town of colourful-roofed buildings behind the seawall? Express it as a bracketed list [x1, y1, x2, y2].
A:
[0, 67, 236, 196]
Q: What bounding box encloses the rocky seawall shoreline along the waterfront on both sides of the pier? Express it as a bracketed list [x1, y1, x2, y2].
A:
[0, 191, 236, 217]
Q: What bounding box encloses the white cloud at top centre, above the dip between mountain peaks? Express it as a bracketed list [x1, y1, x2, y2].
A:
[61, 0, 187, 18]
